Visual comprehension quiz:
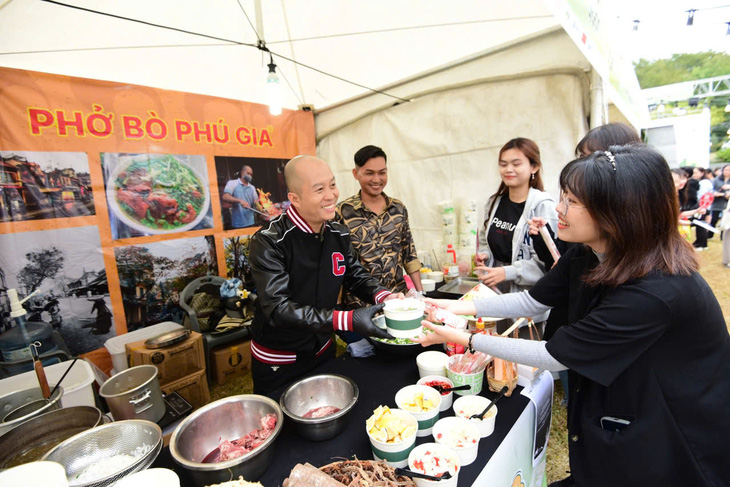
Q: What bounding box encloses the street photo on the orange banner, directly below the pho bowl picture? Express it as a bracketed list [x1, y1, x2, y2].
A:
[114, 236, 218, 331]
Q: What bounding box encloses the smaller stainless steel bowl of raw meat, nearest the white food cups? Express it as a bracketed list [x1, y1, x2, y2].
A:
[279, 374, 360, 441]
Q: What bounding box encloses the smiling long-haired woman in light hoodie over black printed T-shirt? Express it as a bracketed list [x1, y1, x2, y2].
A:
[475, 137, 557, 332]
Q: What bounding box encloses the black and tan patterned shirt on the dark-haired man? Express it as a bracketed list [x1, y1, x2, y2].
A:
[335, 192, 421, 308]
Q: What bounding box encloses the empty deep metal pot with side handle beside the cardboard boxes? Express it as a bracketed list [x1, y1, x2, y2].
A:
[99, 365, 165, 423]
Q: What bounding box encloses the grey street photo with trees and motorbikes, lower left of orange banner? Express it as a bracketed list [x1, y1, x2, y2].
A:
[0, 226, 116, 355]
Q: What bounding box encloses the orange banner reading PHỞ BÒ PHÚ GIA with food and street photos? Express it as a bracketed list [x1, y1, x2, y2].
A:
[0, 68, 316, 369]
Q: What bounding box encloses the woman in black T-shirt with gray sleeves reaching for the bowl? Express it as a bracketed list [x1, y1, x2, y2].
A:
[415, 146, 730, 487]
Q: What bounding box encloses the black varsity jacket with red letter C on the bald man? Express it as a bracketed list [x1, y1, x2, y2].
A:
[249, 207, 390, 357]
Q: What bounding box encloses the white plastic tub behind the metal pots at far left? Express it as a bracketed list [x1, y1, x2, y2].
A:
[0, 360, 96, 408]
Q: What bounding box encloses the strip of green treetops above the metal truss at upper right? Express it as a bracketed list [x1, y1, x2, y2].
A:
[634, 51, 730, 89]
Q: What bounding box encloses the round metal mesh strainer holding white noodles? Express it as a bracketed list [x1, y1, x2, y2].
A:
[43, 419, 162, 487]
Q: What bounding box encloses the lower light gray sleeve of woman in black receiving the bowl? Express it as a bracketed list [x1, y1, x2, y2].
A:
[472, 334, 568, 372]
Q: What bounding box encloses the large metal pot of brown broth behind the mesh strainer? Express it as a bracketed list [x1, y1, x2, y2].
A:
[0, 406, 101, 469]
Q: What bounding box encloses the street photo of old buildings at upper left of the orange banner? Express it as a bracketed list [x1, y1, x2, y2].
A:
[0, 151, 95, 222]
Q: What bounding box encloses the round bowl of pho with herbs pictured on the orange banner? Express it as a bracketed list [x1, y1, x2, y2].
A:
[106, 154, 210, 235]
